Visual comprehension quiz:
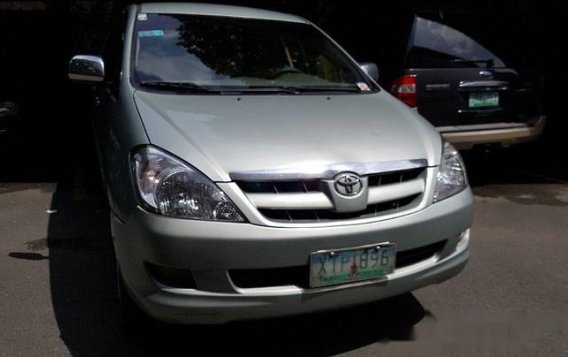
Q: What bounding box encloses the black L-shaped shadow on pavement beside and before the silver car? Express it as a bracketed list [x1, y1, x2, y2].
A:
[44, 181, 425, 356]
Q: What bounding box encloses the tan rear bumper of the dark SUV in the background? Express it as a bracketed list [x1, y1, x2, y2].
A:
[436, 116, 546, 150]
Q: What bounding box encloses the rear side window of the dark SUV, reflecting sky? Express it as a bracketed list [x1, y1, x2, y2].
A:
[406, 16, 505, 68]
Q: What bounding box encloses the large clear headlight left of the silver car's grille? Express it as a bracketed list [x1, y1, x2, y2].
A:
[132, 146, 245, 222]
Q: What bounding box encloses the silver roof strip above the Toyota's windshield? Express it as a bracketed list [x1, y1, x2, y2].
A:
[140, 3, 308, 23]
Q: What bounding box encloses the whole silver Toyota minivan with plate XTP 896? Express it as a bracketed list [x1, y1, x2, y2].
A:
[69, 3, 473, 324]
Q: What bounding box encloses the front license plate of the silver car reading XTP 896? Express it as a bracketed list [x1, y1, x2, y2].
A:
[310, 243, 396, 288]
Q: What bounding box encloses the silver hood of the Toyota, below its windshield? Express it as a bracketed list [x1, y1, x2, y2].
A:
[134, 91, 441, 182]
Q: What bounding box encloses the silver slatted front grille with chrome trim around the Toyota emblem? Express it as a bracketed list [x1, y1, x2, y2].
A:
[235, 160, 427, 223]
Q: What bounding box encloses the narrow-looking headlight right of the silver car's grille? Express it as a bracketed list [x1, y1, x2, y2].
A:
[434, 142, 467, 202]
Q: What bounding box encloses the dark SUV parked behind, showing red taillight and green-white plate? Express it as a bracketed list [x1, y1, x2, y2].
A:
[383, 12, 545, 149]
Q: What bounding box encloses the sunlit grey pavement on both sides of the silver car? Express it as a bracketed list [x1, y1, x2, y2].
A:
[0, 149, 568, 356]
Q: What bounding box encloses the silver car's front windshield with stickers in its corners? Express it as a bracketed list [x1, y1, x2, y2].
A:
[133, 14, 377, 92]
